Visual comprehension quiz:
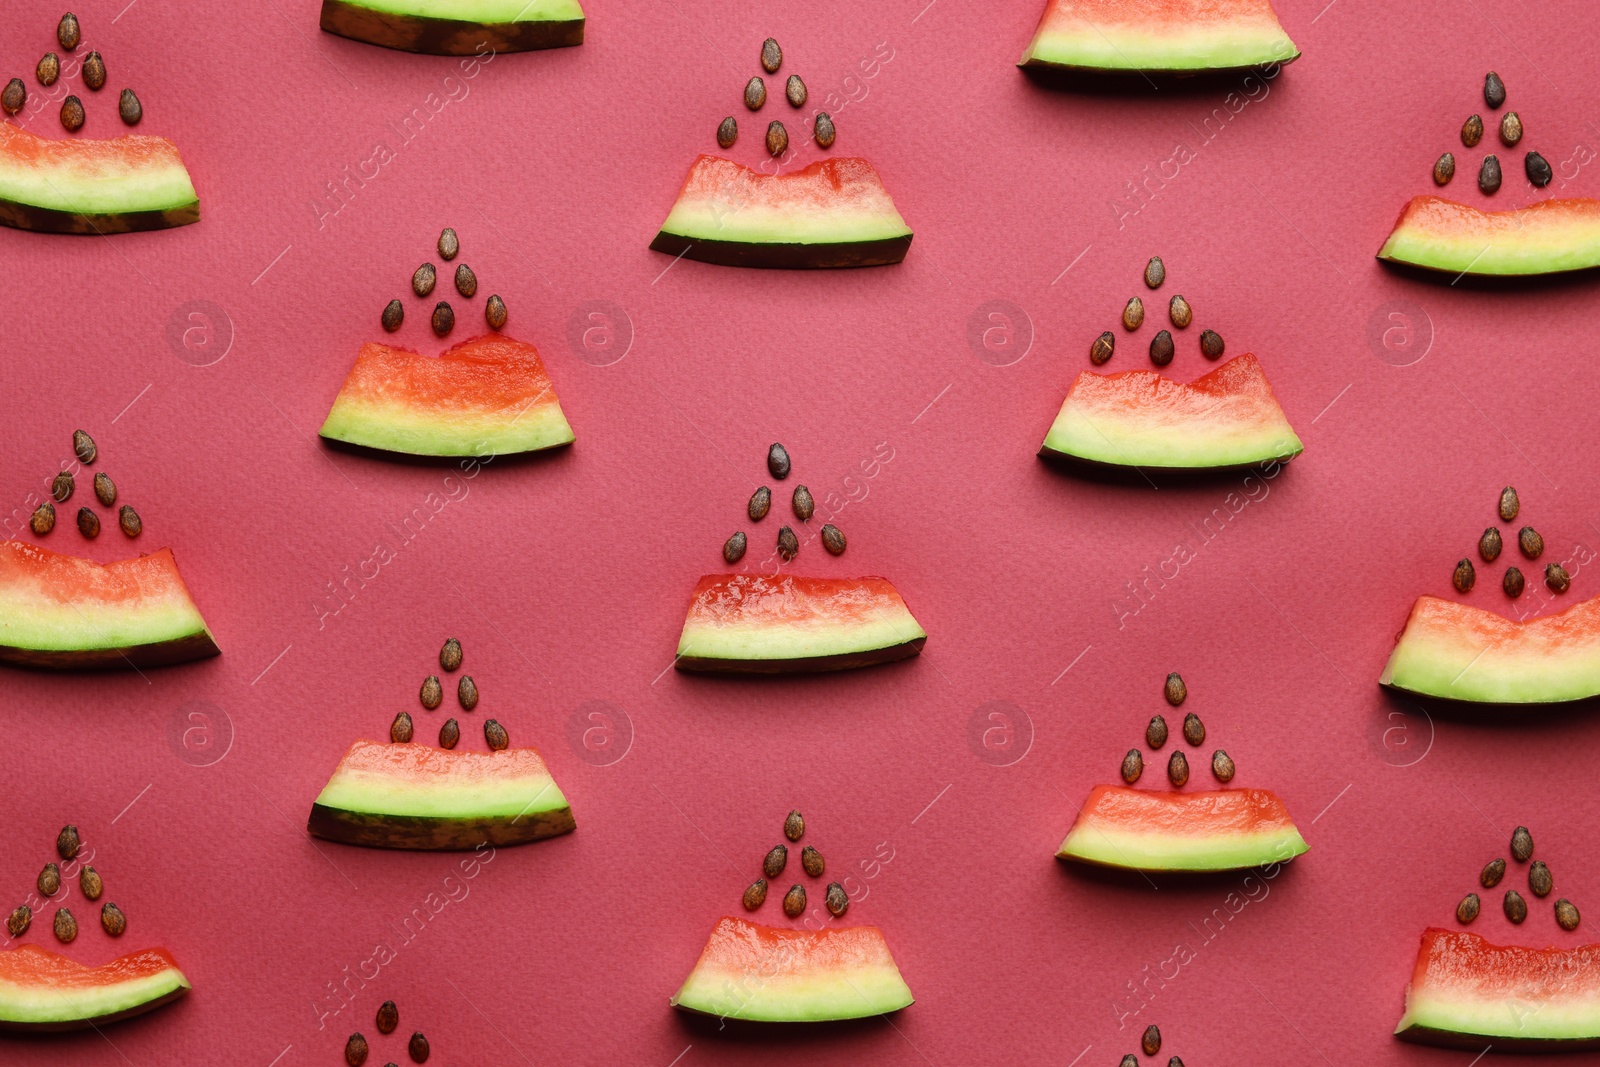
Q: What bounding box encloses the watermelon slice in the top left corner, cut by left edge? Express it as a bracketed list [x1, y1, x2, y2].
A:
[0, 122, 200, 234]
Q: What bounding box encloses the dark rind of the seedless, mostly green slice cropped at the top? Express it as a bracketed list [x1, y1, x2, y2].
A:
[322, 0, 584, 56]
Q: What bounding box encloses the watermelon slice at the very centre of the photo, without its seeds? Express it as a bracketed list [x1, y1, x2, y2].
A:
[675, 574, 928, 673]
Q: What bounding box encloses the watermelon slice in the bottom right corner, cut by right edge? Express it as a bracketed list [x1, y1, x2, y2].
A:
[1395, 926, 1600, 1053]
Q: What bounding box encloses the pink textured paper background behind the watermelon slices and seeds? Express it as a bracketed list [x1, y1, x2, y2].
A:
[0, 0, 1600, 1067]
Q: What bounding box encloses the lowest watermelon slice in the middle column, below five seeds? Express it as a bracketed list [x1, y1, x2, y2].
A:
[672, 917, 912, 1022]
